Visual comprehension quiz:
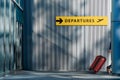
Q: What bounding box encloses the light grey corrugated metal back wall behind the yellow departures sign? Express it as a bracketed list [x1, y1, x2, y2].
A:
[27, 0, 110, 71]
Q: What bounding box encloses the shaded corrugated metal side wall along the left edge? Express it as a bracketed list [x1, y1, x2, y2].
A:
[0, 0, 23, 75]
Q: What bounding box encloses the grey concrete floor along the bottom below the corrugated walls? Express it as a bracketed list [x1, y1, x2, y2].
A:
[0, 71, 120, 80]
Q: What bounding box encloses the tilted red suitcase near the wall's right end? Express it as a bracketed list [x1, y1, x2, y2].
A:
[89, 55, 106, 73]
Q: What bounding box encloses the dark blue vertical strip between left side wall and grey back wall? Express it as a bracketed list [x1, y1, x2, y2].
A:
[22, 0, 33, 70]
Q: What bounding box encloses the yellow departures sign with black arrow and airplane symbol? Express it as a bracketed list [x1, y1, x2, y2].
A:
[56, 16, 108, 26]
